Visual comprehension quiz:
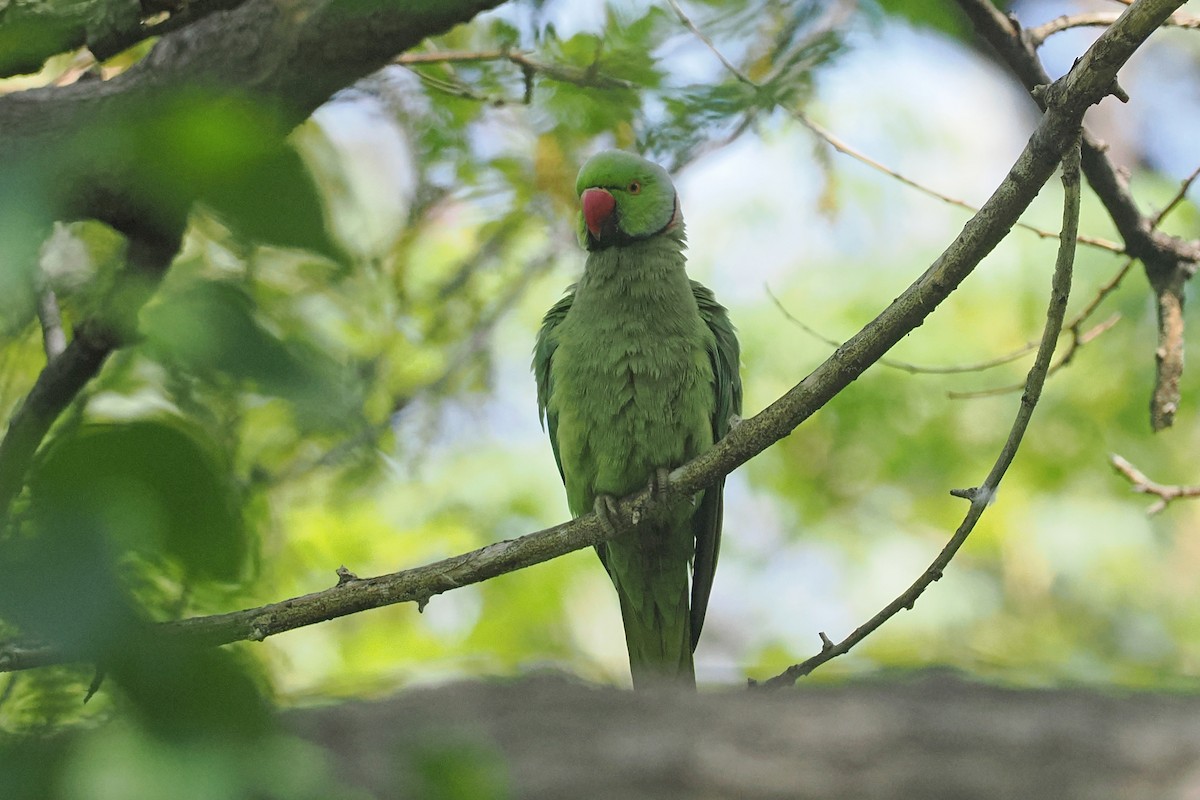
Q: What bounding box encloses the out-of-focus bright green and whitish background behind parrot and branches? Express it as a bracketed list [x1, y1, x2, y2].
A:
[0, 0, 1200, 743]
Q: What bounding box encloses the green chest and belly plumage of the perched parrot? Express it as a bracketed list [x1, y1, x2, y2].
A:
[547, 242, 714, 525]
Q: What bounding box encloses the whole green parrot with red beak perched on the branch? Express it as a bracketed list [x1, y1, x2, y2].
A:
[533, 150, 742, 688]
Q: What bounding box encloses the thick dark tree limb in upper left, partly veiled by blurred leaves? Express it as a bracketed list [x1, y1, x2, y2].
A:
[0, 0, 500, 237]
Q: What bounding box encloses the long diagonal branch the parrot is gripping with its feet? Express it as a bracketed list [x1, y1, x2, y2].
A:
[0, 0, 1182, 670]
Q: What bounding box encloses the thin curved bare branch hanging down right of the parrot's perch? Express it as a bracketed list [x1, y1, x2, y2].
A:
[764, 133, 1094, 687]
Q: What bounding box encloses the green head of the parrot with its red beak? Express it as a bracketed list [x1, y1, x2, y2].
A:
[575, 150, 682, 249]
